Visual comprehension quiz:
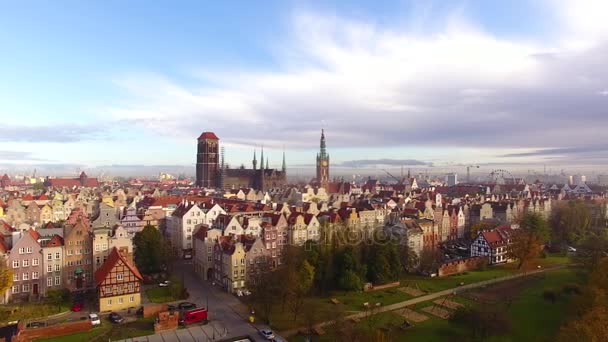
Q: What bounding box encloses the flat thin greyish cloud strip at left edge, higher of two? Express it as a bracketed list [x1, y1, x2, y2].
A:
[0, 124, 107, 143]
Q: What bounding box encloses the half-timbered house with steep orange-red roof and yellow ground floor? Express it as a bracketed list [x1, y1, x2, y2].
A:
[95, 247, 143, 312]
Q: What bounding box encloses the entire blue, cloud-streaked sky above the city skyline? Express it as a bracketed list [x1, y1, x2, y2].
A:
[0, 0, 608, 179]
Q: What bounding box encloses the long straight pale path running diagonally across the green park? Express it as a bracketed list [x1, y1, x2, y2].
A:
[280, 265, 569, 338]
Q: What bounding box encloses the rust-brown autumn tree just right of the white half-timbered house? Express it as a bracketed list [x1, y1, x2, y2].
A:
[509, 213, 549, 269]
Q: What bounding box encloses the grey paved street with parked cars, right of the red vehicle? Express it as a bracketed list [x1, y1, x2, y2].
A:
[114, 261, 265, 342]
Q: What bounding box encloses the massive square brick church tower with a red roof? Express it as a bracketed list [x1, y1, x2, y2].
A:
[196, 132, 220, 188]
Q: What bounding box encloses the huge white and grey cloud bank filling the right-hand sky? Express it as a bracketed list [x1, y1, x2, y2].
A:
[105, 1, 608, 159]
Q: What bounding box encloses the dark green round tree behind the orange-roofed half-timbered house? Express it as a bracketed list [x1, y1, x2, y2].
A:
[133, 225, 170, 274]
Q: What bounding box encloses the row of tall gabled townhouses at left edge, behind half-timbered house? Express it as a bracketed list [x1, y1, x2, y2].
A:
[0, 221, 133, 302]
